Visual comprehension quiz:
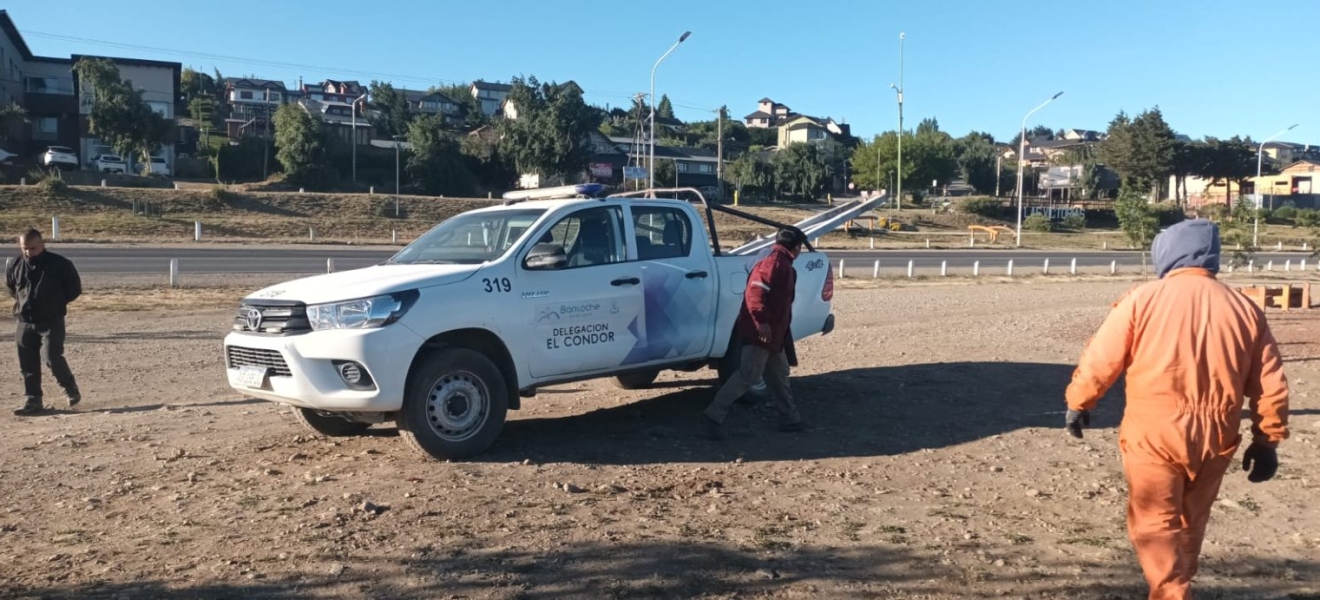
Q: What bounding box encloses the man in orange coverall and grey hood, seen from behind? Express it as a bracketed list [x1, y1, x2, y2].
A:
[1067, 219, 1288, 600]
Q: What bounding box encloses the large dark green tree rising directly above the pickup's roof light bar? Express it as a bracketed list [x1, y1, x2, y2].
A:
[498, 76, 599, 177]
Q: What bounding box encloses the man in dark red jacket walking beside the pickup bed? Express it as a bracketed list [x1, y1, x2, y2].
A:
[702, 228, 807, 439]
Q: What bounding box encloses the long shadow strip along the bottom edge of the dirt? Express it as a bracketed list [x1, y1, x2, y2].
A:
[0, 541, 1320, 600]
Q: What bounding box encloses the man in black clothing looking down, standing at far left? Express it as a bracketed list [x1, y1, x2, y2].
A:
[5, 229, 82, 415]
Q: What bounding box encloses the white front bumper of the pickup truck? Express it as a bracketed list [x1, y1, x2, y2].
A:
[224, 323, 425, 413]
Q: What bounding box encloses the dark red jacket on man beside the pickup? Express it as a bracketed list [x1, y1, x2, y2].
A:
[737, 244, 797, 352]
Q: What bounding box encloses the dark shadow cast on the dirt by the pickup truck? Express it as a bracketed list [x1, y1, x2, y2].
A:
[477, 363, 1108, 464]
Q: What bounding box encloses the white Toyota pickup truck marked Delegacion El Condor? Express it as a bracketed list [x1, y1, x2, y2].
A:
[224, 185, 880, 459]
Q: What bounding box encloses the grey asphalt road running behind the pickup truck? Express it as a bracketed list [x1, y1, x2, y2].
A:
[43, 245, 1316, 274]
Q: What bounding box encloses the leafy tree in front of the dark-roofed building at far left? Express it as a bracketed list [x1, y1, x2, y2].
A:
[74, 58, 172, 175]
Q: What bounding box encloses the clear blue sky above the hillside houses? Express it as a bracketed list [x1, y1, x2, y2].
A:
[3, 0, 1320, 142]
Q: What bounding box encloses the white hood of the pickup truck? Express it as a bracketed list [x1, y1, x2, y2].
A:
[244, 265, 482, 305]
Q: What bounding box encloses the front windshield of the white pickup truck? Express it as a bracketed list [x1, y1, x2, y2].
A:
[387, 208, 545, 265]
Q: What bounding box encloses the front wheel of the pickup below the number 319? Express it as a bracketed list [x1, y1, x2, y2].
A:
[396, 348, 508, 460]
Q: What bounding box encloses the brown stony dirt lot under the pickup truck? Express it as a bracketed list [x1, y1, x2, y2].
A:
[0, 282, 1320, 599]
